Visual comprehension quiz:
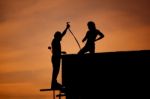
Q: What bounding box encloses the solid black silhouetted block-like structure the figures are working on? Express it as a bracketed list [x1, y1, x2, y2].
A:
[62, 50, 150, 99]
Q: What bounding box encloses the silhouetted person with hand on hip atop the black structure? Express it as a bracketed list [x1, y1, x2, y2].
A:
[78, 21, 104, 54]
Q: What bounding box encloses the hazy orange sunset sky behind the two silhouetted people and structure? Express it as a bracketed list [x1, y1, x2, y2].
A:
[0, 0, 150, 99]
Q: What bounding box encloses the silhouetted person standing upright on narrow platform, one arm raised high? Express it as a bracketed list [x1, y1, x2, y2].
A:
[48, 24, 70, 89]
